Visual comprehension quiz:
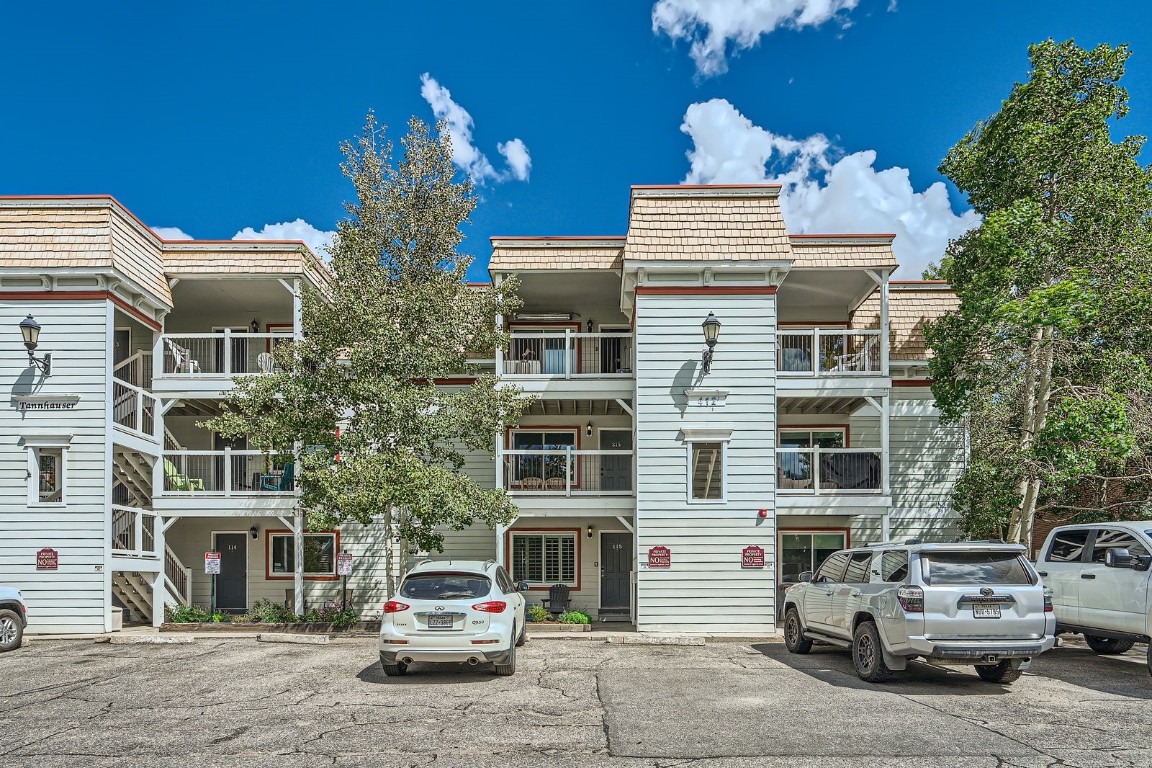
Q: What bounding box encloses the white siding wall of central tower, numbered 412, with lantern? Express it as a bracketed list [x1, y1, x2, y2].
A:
[636, 294, 775, 633]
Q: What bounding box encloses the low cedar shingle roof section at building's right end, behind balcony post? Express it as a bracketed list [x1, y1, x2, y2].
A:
[849, 280, 960, 360]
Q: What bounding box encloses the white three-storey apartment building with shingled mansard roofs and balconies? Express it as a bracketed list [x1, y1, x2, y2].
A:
[0, 185, 964, 634]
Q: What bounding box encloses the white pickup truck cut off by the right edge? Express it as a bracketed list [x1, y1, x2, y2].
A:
[1037, 520, 1152, 675]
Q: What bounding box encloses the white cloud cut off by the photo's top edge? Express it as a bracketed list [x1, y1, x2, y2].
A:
[652, 0, 859, 77]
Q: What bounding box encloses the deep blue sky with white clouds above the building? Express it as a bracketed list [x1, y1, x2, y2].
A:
[0, 0, 1152, 277]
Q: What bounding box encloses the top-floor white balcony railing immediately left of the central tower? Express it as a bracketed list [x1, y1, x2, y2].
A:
[497, 329, 635, 379]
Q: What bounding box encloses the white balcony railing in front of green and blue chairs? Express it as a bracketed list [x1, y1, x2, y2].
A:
[159, 448, 296, 496]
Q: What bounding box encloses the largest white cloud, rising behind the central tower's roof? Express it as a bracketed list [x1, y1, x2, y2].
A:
[681, 99, 980, 279]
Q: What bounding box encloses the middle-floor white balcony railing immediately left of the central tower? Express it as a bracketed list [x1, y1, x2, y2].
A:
[502, 448, 634, 496]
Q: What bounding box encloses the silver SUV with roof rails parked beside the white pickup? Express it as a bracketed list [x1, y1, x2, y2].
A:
[785, 541, 1055, 683]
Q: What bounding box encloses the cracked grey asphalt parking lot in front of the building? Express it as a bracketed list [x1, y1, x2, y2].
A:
[0, 638, 1152, 768]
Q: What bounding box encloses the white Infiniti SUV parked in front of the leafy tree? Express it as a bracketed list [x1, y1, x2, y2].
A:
[380, 560, 528, 676]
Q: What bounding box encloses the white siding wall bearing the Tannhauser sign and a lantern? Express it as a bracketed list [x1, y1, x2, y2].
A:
[0, 294, 111, 633]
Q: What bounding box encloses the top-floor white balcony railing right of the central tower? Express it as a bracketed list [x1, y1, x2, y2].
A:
[776, 328, 882, 377]
